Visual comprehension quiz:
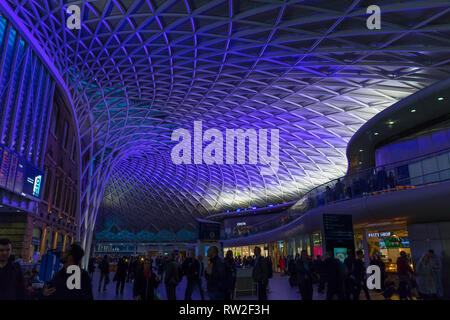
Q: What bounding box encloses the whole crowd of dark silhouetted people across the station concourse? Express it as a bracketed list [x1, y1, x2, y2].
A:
[0, 239, 443, 300]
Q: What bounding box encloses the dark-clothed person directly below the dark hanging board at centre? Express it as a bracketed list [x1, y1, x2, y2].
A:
[205, 246, 227, 300]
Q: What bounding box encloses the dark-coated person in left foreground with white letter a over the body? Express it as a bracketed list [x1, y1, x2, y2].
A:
[42, 244, 94, 300]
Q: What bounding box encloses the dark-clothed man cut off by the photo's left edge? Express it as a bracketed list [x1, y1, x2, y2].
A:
[0, 239, 25, 300]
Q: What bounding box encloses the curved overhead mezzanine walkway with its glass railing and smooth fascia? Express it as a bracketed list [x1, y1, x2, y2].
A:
[223, 149, 450, 247]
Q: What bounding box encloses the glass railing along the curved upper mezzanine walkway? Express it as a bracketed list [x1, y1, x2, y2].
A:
[226, 149, 450, 239]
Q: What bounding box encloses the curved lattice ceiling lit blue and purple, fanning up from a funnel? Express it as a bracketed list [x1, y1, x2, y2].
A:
[7, 0, 450, 232]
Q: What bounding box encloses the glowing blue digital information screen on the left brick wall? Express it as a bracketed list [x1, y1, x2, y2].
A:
[0, 145, 44, 198]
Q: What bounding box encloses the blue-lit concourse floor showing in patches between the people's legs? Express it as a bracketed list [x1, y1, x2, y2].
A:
[92, 271, 390, 300]
